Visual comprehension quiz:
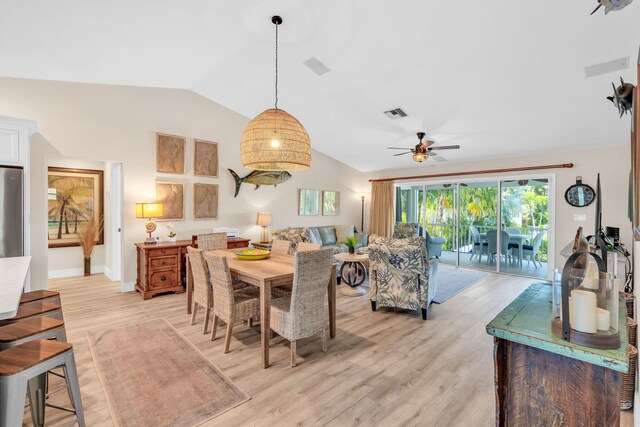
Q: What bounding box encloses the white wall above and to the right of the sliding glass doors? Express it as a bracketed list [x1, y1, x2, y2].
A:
[367, 143, 633, 267]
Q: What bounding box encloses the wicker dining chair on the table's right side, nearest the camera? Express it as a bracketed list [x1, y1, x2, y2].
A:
[271, 249, 333, 366]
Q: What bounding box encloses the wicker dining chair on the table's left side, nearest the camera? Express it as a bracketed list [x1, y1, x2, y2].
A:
[204, 253, 260, 354]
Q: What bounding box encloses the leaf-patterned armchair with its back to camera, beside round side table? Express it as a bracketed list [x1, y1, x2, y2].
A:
[369, 236, 440, 320]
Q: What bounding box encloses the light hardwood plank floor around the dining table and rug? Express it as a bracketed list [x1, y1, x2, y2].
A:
[25, 274, 633, 427]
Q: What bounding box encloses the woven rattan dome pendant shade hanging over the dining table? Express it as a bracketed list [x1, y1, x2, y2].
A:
[240, 108, 311, 171]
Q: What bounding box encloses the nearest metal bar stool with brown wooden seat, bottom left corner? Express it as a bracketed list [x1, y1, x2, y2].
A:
[0, 340, 85, 427]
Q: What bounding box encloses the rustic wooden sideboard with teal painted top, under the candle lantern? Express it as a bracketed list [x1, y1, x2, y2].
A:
[487, 282, 629, 427]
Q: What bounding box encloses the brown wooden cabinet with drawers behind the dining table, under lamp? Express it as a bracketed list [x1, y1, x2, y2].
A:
[136, 236, 250, 299]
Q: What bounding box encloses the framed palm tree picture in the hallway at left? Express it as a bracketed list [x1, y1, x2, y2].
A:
[47, 167, 104, 248]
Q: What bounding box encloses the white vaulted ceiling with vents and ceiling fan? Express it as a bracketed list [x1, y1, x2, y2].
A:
[0, 0, 640, 171]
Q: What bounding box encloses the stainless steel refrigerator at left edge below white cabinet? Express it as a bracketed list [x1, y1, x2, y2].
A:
[0, 166, 24, 258]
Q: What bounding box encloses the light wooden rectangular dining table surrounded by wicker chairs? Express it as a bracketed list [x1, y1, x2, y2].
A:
[187, 249, 337, 368]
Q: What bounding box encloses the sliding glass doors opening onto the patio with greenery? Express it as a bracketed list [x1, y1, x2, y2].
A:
[396, 177, 552, 278]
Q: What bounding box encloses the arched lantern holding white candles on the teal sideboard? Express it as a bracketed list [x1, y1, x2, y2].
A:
[551, 249, 620, 349]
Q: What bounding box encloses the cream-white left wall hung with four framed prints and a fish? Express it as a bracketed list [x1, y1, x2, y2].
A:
[0, 78, 364, 285]
